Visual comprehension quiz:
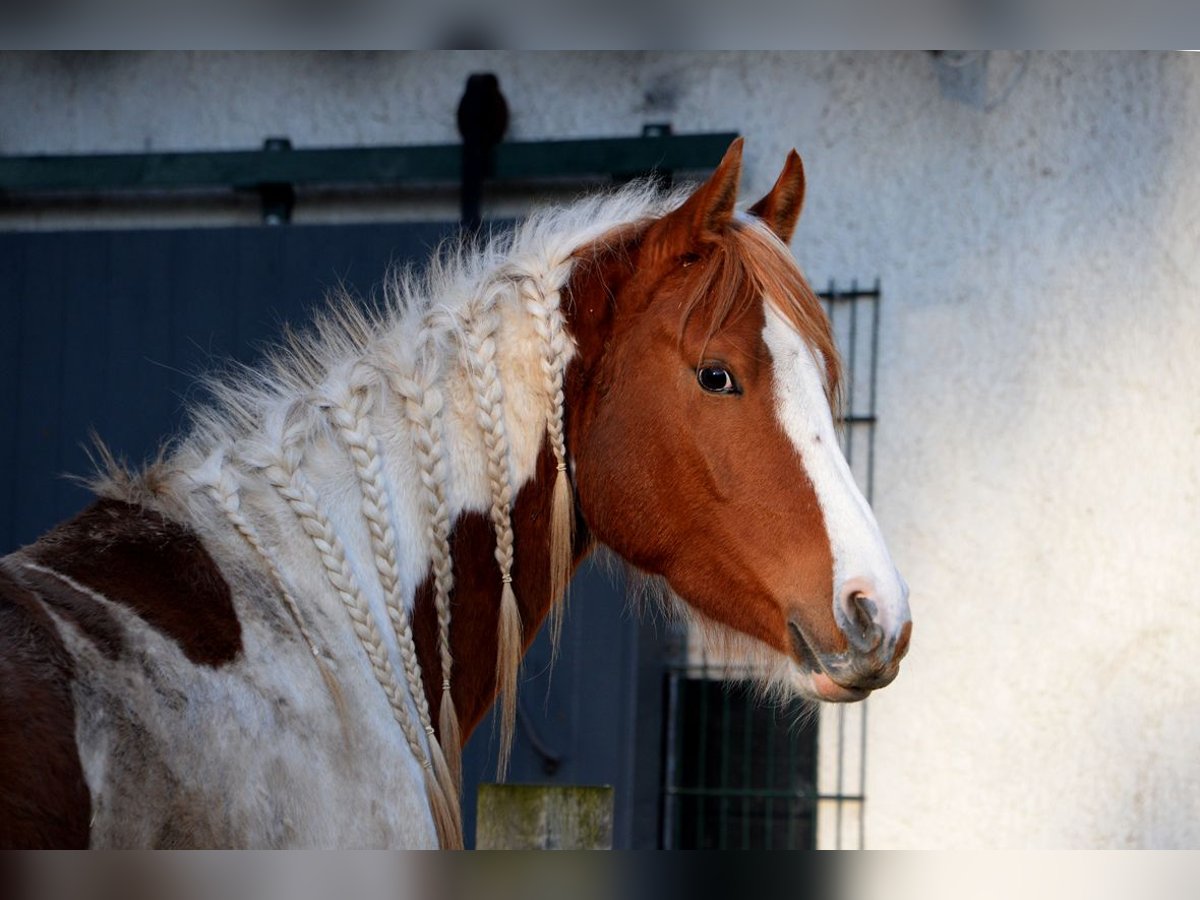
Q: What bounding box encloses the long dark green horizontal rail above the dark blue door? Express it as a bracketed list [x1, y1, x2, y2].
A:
[0, 132, 737, 193]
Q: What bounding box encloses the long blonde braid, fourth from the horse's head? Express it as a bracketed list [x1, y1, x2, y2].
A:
[329, 374, 462, 844]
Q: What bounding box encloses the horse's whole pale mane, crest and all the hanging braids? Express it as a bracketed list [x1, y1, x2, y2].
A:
[84, 181, 682, 846]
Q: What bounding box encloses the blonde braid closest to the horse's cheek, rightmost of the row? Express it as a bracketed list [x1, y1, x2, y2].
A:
[518, 263, 575, 654]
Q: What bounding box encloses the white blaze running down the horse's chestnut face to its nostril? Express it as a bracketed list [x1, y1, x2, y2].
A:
[763, 302, 910, 641]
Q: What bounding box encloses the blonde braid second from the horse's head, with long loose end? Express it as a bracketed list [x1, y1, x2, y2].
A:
[464, 294, 521, 781]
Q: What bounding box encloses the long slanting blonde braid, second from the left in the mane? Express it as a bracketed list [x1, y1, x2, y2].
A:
[263, 420, 461, 848]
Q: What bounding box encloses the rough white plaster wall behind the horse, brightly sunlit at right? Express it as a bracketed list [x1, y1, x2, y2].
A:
[0, 53, 1200, 847]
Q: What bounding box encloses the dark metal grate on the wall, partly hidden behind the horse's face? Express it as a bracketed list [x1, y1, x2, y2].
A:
[660, 281, 881, 850]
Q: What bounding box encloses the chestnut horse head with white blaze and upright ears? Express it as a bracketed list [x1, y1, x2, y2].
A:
[564, 139, 911, 701]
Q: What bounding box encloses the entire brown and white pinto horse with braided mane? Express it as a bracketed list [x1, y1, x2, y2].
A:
[0, 139, 911, 848]
